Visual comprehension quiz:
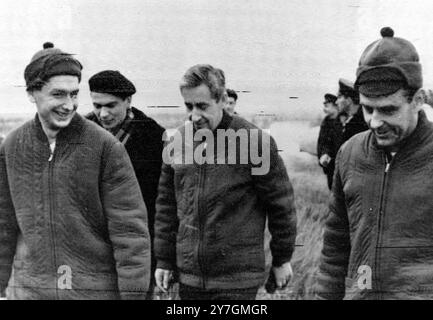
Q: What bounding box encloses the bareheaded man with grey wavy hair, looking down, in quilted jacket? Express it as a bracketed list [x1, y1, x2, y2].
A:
[155, 65, 296, 300]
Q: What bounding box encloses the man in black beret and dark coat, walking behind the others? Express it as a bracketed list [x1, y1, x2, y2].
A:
[86, 70, 164, 299]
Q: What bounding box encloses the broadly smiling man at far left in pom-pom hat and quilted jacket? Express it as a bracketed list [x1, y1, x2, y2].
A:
[0, 45, 150, 299]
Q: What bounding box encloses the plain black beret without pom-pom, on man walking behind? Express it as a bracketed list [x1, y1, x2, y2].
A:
[89, 70, 136, 99]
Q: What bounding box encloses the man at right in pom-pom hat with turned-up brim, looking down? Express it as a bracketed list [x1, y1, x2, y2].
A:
[316, 28, 433, 299]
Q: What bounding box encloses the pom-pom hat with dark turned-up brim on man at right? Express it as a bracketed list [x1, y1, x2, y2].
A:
[355, 27, 422, 97]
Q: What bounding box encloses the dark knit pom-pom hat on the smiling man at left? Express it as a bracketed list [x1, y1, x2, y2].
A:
[24, 42, 83, 91]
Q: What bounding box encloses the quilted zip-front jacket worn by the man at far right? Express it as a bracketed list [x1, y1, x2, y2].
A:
[316, 111, 433, 299]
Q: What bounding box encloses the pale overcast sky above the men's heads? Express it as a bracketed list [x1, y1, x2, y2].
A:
[0, 0, 433, 117]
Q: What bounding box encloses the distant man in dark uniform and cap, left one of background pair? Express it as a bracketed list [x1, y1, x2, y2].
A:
[317, 93, 339, 189]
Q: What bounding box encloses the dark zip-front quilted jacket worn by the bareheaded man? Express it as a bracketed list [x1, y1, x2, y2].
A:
[155, 112, 296, 289]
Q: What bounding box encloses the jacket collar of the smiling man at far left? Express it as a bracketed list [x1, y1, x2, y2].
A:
[34, 112, 85, 144]
